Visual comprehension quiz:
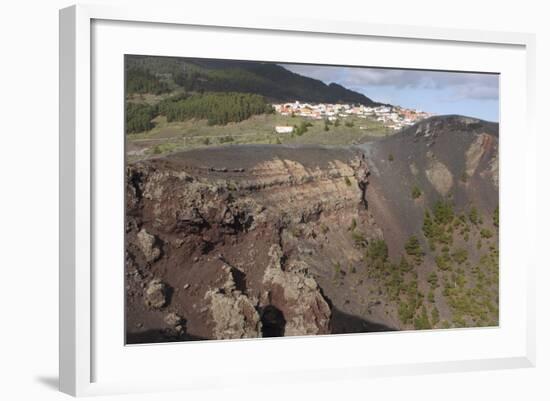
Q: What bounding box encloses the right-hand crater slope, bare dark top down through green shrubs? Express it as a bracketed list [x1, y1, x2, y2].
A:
[364, 116, 499, 327]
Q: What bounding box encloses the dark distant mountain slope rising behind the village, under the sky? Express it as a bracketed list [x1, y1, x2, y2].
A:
[125, 56, 379, 106]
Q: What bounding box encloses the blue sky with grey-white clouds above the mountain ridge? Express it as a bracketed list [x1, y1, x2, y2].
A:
[283, 64, 499, 121]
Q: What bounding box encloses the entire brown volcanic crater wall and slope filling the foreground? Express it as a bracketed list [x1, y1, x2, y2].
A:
[126, 116, 498, 343]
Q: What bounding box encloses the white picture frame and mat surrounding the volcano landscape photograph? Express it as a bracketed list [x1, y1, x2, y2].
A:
[59, 5, 536, 396]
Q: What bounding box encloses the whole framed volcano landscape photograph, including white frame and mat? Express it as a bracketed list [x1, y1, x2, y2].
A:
[60, 6, 536, 395]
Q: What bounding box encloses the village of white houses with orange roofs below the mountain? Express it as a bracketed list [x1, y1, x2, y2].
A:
[273, 101, 433, 133]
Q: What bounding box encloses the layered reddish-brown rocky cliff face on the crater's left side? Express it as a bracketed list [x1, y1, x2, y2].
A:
[126, 147, 381, 341]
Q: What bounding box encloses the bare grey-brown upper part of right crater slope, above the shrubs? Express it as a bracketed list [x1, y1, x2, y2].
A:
[363, 116, 498, 255]
